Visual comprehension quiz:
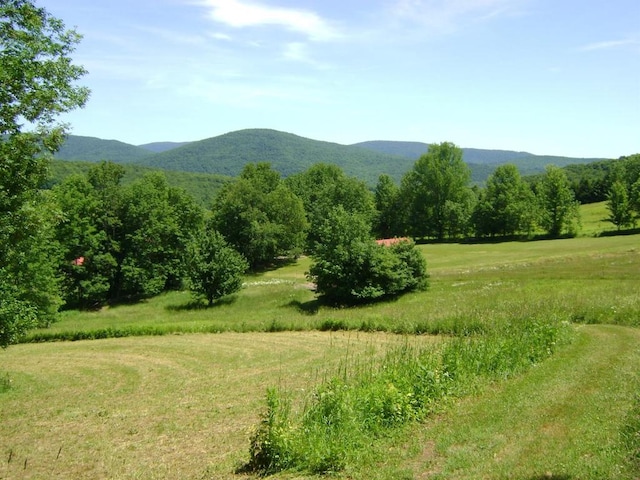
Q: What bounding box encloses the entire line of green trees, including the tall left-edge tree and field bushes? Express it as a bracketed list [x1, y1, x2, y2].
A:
[0, 0, 640, 346]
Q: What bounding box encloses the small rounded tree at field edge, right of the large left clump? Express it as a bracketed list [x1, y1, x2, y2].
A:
[187, 225, 249, 306]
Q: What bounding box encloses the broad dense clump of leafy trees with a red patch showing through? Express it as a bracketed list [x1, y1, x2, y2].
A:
[53, 162, 203, 308]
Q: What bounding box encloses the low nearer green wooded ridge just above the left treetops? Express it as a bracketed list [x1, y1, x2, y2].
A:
[44, 160, 233, 207]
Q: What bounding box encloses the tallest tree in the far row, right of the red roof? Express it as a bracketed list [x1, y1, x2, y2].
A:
[400, 142, 473, 240]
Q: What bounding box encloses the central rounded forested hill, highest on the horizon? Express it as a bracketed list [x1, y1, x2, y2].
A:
[137, 129, 413, 185]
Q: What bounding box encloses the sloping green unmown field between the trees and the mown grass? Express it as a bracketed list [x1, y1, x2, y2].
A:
[30, 235, 640, 339]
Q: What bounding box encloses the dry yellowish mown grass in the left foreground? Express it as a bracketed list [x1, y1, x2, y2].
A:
[0, 332, 430, 479]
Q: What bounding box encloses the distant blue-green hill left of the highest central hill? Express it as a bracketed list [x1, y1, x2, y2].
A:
[55, 135, 153, 163]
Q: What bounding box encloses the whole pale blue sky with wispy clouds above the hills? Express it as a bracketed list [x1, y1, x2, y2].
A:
[36, 0, 640, 158]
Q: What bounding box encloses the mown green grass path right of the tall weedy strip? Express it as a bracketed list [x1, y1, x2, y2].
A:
[400, 325, 640, 480]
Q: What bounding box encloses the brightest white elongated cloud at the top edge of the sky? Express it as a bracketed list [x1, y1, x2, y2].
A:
[199, 0, 340, 41]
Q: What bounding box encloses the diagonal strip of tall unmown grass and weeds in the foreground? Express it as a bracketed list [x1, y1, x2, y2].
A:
[247, 318, 572, 474]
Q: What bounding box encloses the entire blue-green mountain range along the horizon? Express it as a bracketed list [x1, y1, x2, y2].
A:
[56, 129, 602, 186]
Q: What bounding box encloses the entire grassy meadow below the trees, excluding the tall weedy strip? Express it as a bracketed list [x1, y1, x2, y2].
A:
[0, 201, 640, 480]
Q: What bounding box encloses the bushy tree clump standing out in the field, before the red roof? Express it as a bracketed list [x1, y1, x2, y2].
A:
[308, 207, 427, 304]
